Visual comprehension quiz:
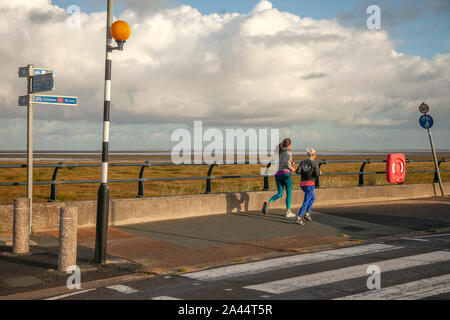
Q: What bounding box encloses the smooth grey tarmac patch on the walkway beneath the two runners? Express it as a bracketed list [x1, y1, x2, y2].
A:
[118, 211, 409, 248]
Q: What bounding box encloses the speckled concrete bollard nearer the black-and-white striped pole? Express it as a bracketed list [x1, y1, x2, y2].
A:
[58, 207, 78, 272]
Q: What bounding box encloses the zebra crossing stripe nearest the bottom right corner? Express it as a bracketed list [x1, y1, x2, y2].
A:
[335, 274, 450, 300]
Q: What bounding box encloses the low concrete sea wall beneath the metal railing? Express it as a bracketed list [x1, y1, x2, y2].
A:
[0, 182, 450, 233]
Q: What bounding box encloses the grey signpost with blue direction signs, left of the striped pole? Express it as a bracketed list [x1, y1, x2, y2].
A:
[18, 64, 78, 233]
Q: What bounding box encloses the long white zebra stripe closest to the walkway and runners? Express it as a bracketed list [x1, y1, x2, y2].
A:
[183, 243, 401, 281]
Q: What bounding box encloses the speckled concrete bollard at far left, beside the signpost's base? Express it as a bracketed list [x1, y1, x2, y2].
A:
[13, 198, 30, 253]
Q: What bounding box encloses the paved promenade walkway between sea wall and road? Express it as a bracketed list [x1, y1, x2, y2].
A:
[0, 198, 450, 296]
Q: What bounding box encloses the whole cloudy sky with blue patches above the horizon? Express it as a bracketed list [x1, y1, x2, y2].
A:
[0, 0, 450, 150]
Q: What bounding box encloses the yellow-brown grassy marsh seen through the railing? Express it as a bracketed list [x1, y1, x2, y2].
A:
[0, 155, 450, 204]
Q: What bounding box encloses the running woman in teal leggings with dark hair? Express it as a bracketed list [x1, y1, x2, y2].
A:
[262, 138, 296, 218]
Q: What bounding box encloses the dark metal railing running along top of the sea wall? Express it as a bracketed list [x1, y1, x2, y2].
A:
[0, 159, 450, 201]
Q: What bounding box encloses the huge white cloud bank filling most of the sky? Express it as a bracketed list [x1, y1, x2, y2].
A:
[0, 0, 450, 149]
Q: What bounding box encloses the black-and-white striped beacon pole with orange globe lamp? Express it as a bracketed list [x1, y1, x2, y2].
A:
[95, 0, 131, 264]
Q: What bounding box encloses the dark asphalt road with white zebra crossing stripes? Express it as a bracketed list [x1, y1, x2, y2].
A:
[43, 233, 450, 300]
